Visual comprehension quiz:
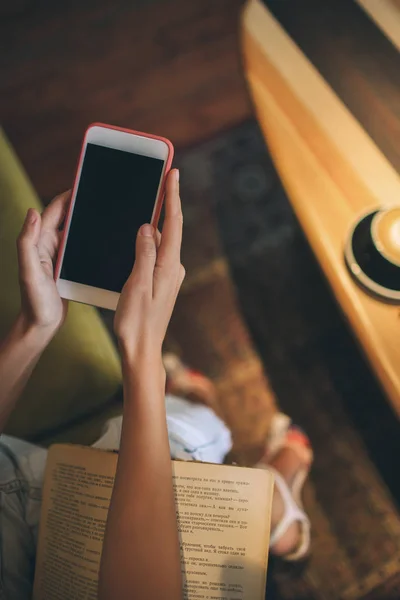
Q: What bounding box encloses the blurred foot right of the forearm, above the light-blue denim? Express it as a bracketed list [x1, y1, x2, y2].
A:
[163, 353, 216, 409]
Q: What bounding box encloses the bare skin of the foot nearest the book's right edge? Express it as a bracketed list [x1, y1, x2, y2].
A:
[261, 428, 312, 558]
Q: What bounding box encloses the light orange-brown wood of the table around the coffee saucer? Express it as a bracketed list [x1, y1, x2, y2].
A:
[242, 0, 400, 414]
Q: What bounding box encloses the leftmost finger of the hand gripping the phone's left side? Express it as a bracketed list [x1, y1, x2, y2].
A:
[17, 208, 41, 281]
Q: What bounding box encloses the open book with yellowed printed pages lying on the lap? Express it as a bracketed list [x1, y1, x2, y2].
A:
[33, 445, 273, 600]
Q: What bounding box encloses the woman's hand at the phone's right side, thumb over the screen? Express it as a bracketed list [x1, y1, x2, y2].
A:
[114, 169, 185, 369]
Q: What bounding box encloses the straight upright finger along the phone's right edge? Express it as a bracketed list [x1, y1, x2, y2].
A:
[157, 169, 183, 268]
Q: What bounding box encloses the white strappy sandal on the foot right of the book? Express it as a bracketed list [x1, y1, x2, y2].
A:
[257, 413, 313, 562]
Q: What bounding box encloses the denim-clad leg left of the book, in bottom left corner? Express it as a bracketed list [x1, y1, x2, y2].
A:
[0, 435, 47, 600]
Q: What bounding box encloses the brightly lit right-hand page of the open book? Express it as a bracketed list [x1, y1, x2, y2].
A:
[174, 462, 273, 600]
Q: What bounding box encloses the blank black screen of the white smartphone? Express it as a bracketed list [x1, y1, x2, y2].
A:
[60, 144, 164, 292]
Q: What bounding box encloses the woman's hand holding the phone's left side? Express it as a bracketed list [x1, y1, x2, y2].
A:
[17, 191, 71, 339]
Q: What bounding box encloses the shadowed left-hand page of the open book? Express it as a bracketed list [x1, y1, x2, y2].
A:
[33, 445, 118, 600]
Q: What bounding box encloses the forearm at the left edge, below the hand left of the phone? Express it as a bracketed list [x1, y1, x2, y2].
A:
[0, 316, 52, 433]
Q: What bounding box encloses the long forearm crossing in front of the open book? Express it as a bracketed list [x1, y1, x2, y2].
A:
[99, 360, 182, 600]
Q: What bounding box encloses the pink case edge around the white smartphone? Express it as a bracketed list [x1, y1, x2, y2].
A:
[54, 123, 174, 280]
